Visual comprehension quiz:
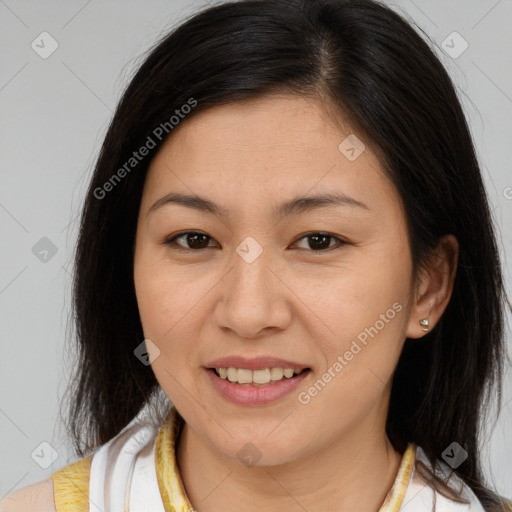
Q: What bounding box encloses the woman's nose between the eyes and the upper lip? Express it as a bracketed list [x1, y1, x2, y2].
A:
[214, 244, 293, 339]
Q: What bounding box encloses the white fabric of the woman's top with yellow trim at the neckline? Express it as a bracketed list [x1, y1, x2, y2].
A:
[89, 409, 485, 512]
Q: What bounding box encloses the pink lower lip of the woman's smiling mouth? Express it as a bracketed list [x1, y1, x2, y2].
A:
[206, 368, 310, 406]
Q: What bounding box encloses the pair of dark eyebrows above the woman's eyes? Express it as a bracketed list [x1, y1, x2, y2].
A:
[146, 192, 369, 219]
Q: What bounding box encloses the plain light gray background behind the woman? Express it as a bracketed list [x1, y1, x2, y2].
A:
[0, 0, 512, 498]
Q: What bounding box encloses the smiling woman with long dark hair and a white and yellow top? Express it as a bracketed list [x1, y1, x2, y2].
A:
[4, 0, 512, 512]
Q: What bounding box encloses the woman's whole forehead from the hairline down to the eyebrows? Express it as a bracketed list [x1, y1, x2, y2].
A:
[140, 95, 396, 216]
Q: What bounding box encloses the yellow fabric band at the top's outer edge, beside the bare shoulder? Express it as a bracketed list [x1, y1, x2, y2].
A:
[50, 455, 92, 512]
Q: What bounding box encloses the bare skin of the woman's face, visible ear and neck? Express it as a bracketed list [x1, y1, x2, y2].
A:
[134, 95, 458, 512]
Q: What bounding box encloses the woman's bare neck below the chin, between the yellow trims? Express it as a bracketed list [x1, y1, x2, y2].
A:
[176, 415, 402, 512]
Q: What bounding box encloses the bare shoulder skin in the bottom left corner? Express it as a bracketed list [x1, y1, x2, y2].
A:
[0, 478, 56, 512]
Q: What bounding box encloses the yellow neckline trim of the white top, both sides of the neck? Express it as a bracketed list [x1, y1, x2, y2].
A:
[155, 407, 416, 512]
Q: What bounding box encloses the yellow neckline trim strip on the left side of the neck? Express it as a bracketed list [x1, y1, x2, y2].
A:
[155, 407, 194, 512]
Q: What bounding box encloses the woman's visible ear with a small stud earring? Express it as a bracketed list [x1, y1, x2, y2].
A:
[406, 235, 459, 338]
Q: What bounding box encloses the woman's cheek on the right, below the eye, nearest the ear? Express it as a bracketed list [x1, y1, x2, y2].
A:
[304, 238, 411, 398]
